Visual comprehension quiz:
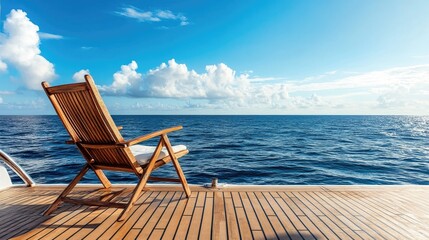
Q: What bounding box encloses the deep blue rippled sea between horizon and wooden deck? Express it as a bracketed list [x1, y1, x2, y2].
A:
[0, 116, 429, 185]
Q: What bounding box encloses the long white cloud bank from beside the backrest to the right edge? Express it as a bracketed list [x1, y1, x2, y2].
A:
[96, 59, 429, 114]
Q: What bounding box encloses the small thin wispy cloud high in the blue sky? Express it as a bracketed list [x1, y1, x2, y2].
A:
[116, 6, 189, 26]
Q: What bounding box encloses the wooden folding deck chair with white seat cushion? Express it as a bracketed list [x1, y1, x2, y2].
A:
[42, 75, 191, 221]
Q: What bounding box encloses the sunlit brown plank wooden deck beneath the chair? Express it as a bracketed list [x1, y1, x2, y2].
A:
[0, 186, 429, 239]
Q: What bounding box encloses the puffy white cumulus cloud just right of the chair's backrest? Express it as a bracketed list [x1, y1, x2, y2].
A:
[100, 59, 254, 99]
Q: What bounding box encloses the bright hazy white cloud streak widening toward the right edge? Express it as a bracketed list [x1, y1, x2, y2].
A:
[288, 65, 429, 114]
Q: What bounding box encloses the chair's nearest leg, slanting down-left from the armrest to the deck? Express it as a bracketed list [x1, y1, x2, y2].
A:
[117, 139, 163, 222]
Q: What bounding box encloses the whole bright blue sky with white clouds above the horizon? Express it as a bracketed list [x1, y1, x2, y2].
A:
[0, 0, 429, 115]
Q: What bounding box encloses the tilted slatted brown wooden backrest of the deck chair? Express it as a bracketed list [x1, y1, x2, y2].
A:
[42, 75, 142, 173]
